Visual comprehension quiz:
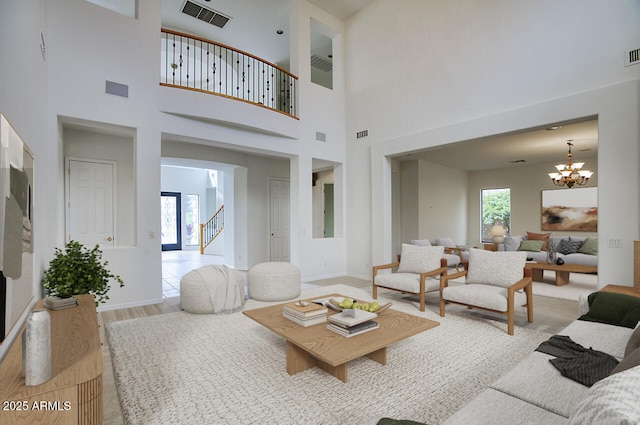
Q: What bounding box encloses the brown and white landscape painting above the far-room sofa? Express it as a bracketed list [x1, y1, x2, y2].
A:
[542, 187, 598, 232]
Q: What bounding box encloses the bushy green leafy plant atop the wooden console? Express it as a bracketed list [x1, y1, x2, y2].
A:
[42, 241, 124, 305]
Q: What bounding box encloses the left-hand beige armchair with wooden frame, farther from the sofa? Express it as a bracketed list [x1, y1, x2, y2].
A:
[371, 244, 447, 311]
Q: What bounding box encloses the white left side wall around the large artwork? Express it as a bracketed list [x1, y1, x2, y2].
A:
[0, 0, 47, 360]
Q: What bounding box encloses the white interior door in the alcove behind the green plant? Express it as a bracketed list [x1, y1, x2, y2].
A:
[67, 159, 116, 247]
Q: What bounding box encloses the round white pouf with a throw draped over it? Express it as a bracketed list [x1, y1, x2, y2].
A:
[180, 265, 244, 313]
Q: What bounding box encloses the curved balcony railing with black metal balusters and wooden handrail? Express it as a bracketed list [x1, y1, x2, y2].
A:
[160, 29, 298, 118]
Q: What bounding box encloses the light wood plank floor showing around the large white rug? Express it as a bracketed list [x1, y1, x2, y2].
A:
[98, 277, 578, 425]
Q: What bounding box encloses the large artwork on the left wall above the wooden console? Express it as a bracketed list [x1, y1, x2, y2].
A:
[0, 114, 36, 342]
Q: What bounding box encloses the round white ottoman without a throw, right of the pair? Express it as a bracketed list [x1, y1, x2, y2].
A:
[248, 262, 300, 301]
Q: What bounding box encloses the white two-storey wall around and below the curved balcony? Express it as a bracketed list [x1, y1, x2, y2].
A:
[35, 0, 346, 309]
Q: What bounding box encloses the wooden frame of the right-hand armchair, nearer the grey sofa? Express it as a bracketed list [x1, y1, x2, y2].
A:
[440, 262, 533, 335]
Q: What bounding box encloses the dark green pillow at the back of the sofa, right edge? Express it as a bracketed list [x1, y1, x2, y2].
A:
[579, 291, 640, 329]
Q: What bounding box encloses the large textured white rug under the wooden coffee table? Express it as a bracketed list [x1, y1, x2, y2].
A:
[106, 285, 549, 425]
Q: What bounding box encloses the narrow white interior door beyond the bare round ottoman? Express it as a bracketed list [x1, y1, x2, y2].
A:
[269, 179, 291, 262]
